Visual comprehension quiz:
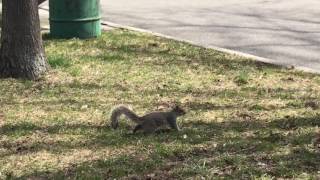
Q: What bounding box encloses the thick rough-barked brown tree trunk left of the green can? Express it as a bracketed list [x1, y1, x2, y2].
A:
[0, 0, 48, 80]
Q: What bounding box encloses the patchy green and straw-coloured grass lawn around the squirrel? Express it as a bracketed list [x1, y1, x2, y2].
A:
[0, 30, 320, 179]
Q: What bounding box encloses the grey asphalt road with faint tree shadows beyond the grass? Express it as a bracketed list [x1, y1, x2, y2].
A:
[101, 0, 320, 72]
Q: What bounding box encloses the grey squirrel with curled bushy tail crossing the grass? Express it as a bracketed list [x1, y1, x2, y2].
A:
[111, 105, 186, 134]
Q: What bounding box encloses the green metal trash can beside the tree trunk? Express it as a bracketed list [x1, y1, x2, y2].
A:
[49, 0, 101, 38]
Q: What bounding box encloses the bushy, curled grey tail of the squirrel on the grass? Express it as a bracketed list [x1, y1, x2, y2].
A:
[111, 105, 140, 129]
